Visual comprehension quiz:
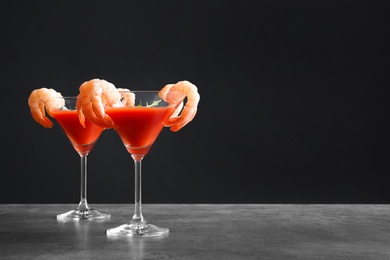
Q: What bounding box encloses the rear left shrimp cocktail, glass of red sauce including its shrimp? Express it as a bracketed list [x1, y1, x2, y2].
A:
[28, 88, 111, 222]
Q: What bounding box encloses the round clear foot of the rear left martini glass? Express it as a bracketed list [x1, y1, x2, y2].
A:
[57, 209, 111, 222]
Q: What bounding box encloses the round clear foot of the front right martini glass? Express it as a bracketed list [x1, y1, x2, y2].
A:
[107, 223, 169, 237]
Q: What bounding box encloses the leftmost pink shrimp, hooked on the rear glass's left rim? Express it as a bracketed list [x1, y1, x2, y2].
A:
[28, 88, 65, 128]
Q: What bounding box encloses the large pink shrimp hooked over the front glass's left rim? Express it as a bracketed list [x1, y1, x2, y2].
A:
[76, 79, 121, 128]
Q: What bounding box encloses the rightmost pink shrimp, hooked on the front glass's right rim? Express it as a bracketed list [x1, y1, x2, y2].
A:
[159, 80, 200, 132]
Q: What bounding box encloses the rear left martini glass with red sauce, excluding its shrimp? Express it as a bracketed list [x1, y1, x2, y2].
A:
[45, 96, 111, 222]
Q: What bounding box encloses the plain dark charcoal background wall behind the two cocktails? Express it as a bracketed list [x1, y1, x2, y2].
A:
[0, 0, 390, 204]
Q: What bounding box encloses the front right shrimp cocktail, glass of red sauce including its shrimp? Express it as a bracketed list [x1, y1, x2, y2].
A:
[78, 79, 200, 237]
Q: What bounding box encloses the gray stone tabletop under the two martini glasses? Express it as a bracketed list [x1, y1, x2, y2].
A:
[0, 204, 390, 260]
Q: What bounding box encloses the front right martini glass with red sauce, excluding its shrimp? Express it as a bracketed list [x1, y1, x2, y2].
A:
[105, 91, 185, 237]
